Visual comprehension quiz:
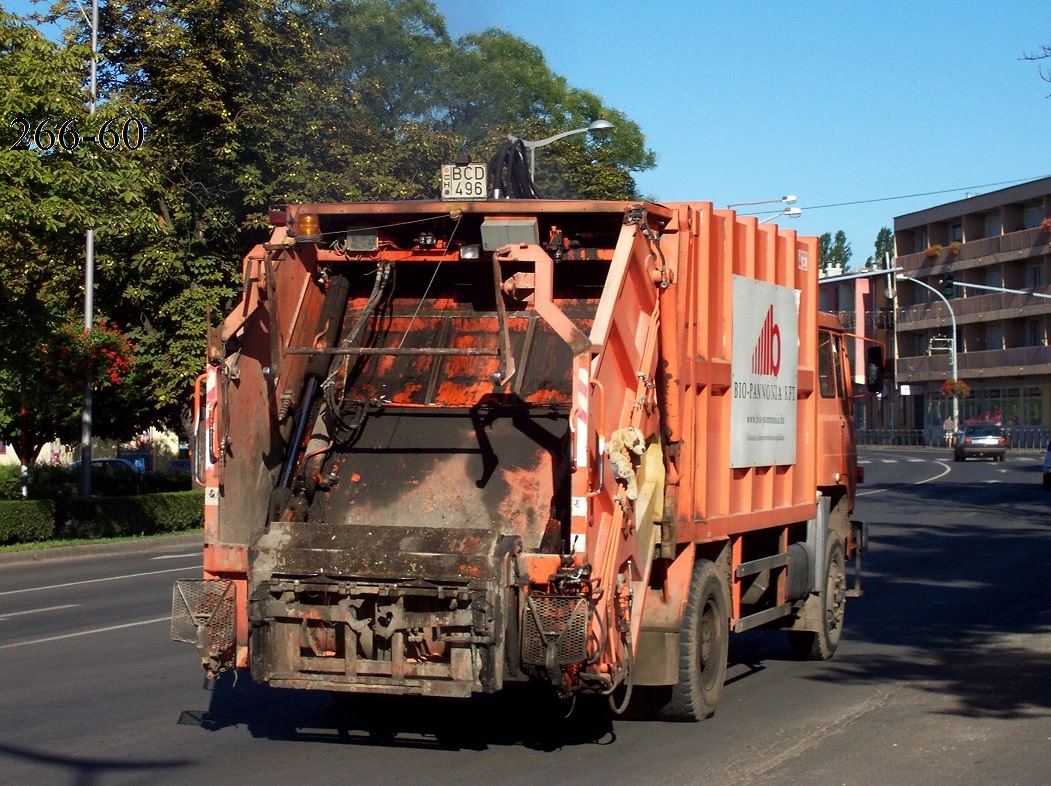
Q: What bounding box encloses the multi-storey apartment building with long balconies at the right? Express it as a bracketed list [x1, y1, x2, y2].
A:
[894, 178, 1051, 430]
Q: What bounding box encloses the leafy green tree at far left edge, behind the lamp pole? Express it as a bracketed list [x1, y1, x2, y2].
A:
[0, 13, 160, 456]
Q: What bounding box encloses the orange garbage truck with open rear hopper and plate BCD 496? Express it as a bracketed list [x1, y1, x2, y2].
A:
[172, 195, 882, 720]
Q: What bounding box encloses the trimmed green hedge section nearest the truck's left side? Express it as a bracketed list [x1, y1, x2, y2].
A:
[60, 490, 204, 538]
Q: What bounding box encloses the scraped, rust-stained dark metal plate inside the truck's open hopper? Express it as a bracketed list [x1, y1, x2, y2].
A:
[314, 409, 569, 551]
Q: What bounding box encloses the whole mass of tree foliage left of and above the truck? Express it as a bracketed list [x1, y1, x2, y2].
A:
[0, 0, 654, 453]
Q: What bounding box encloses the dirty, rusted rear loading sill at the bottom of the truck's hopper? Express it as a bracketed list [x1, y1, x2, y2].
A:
[248, 522, 525, 697]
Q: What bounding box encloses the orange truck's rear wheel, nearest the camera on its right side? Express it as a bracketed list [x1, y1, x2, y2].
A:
[660, 560, 729, 721]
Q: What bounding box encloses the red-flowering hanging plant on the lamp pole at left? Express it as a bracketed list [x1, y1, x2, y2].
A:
[40, 323, 135, 388]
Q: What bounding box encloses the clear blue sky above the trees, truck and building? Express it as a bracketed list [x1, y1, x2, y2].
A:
[10, 0, 1051, 260]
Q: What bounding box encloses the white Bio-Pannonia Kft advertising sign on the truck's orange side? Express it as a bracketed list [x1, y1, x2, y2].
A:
[729, 275, 799, 469]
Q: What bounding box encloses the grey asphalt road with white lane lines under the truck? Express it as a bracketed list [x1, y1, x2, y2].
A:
[0, 449, 1051, 786]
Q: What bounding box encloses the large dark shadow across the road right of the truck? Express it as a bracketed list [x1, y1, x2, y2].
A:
[816, 474, 1051, 719]
